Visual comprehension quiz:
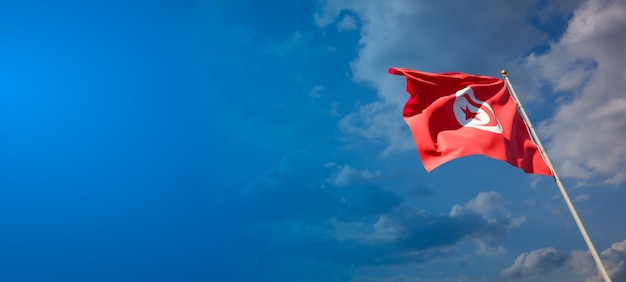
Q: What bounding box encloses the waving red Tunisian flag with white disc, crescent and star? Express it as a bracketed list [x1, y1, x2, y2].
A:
[389, 68, 552, 175]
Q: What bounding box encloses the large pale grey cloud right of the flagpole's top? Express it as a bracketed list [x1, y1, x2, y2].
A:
[527, 0, 626, 184]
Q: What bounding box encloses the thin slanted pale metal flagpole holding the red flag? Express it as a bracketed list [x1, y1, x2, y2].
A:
[502, 70, 611, 282]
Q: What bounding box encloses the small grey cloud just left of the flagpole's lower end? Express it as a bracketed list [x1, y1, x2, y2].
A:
[500, 247, 568, 280]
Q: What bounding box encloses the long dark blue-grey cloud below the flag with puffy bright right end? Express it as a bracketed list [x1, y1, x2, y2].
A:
[333, 192, 523, 265]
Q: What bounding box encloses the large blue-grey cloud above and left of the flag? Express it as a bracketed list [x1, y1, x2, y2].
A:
[315, 0, 546, 157]
